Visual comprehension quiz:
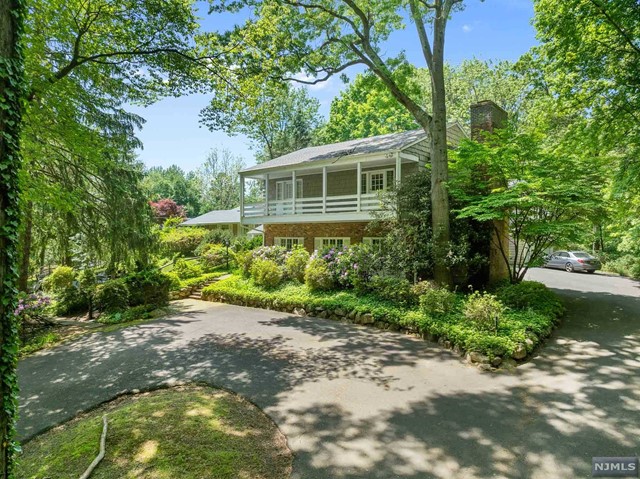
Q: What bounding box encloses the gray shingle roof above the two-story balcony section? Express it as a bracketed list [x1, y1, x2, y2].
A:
[242, 129, 427, 172]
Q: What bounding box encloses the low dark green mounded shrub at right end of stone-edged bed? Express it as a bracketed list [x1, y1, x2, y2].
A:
[496, 281, 564, 317]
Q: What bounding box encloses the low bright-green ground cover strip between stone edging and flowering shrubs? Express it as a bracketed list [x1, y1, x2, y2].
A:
[202, 276, 559, 359]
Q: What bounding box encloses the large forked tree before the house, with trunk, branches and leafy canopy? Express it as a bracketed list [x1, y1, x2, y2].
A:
[212, 0, 470, 284]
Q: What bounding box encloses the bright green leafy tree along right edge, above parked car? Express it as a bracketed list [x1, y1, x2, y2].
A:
[520, 0, 640, 271]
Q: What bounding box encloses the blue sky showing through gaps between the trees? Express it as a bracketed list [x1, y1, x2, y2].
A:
[132, 0, 536, 171]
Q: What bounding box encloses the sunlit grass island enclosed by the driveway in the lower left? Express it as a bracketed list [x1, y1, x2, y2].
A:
[17, 386, 292, 479]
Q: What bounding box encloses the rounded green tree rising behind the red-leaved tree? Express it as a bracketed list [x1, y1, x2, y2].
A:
[140, 165, 200, 217]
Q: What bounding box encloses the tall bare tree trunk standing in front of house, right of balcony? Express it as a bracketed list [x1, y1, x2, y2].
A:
[429, 14, 453, 286]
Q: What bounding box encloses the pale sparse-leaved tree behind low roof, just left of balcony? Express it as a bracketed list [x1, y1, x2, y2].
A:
[196, 149, 244, 211]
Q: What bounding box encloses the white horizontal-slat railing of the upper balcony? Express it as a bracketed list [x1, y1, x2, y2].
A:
[242, 193, 381, 218]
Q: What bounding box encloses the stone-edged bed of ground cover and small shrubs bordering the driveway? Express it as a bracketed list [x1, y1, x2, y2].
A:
[203, 274, 563, 364]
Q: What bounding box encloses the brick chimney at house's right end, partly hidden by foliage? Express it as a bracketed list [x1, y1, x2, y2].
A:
[469, 100, 509, 283]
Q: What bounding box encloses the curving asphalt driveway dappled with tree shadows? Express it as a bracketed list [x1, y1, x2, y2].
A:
[18, 270, 640, 479]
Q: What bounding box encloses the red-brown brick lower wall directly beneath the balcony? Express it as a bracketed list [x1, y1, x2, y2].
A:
[264, 222, 376, 253]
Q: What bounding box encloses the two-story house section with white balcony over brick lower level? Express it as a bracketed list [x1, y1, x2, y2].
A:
[240, 123, 466, 255]
